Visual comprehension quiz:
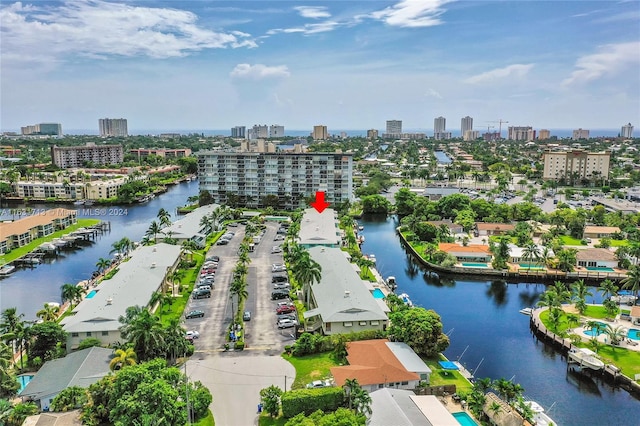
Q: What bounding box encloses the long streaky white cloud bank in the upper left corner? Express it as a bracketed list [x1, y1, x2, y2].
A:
[0, 0, 257, 62]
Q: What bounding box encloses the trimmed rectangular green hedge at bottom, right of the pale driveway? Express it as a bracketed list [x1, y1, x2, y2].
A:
[280, 387, 344, 418]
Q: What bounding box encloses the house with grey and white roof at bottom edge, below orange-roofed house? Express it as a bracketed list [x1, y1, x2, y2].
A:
[367, 388, 460, 426]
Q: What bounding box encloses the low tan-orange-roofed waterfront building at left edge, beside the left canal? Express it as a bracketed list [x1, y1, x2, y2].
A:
[0, 208, 78, 253]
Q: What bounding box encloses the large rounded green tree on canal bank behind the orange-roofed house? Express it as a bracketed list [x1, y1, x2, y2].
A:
[388, 308, 449, 356]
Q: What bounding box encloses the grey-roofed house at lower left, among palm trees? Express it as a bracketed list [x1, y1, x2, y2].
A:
[19, 347, 113, 410]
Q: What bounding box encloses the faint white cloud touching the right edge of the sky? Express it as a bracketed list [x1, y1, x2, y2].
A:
[562, 41, 640, 86]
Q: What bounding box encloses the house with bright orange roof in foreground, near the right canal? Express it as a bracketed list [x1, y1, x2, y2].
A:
[331, 339, 420, 392]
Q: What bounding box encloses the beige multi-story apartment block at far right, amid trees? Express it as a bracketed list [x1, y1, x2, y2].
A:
[542, 150, 611, 180]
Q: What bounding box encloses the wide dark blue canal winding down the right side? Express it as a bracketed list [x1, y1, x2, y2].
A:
[359, 217, 640, 425]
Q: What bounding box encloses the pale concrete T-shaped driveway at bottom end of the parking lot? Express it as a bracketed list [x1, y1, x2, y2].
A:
[186, 352, 296, 426]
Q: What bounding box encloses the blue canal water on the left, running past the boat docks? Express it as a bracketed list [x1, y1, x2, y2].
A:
[0, 181, 198, 320]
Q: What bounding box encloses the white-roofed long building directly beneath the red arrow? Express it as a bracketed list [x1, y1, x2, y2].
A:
[298, 208, 342, 249]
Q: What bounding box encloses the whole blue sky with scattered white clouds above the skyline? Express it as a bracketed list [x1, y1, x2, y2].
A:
[0, 0, 640, 133]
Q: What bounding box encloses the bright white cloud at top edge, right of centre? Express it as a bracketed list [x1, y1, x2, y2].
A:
[369, 0, 452, 27]
